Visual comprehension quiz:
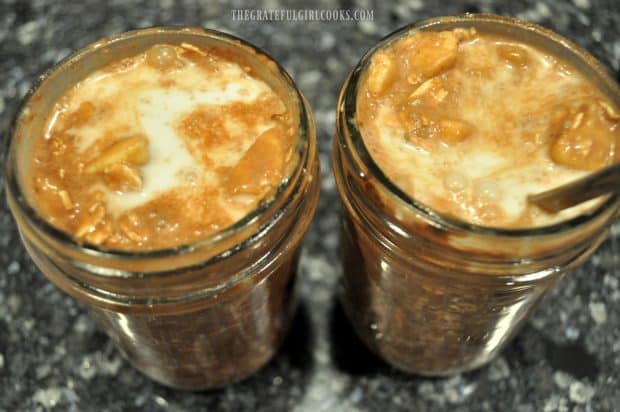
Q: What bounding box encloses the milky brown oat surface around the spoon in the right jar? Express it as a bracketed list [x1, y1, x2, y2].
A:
[357, 29, 620, 227]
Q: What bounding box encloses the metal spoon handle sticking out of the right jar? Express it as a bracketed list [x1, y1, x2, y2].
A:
[527, 163, 620, 213]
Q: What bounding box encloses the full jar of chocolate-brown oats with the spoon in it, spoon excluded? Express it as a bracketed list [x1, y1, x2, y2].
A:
[333, 15, 620, 376]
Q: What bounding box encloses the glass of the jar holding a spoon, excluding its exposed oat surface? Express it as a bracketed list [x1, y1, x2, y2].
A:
[333, 15, 620, 376]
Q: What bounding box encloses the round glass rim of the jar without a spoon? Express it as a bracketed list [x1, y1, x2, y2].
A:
[4, 26, 313, 264]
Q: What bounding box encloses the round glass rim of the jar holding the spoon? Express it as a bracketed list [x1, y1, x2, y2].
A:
[336, 13, 620, 238]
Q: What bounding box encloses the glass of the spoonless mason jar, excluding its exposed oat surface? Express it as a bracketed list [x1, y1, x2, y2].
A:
[6, 28, 320, 389]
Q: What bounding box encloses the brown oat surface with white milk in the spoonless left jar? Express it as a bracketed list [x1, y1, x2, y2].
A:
[32, 44, 295, 250]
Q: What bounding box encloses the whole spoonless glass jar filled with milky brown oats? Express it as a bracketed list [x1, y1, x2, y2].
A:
[7, 28, 320, 389]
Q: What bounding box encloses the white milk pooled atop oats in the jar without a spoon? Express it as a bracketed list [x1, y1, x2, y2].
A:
[50, 52, 274, 214]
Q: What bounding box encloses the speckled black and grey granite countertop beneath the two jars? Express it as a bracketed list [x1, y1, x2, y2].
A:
[0, 0, 620, 412]
